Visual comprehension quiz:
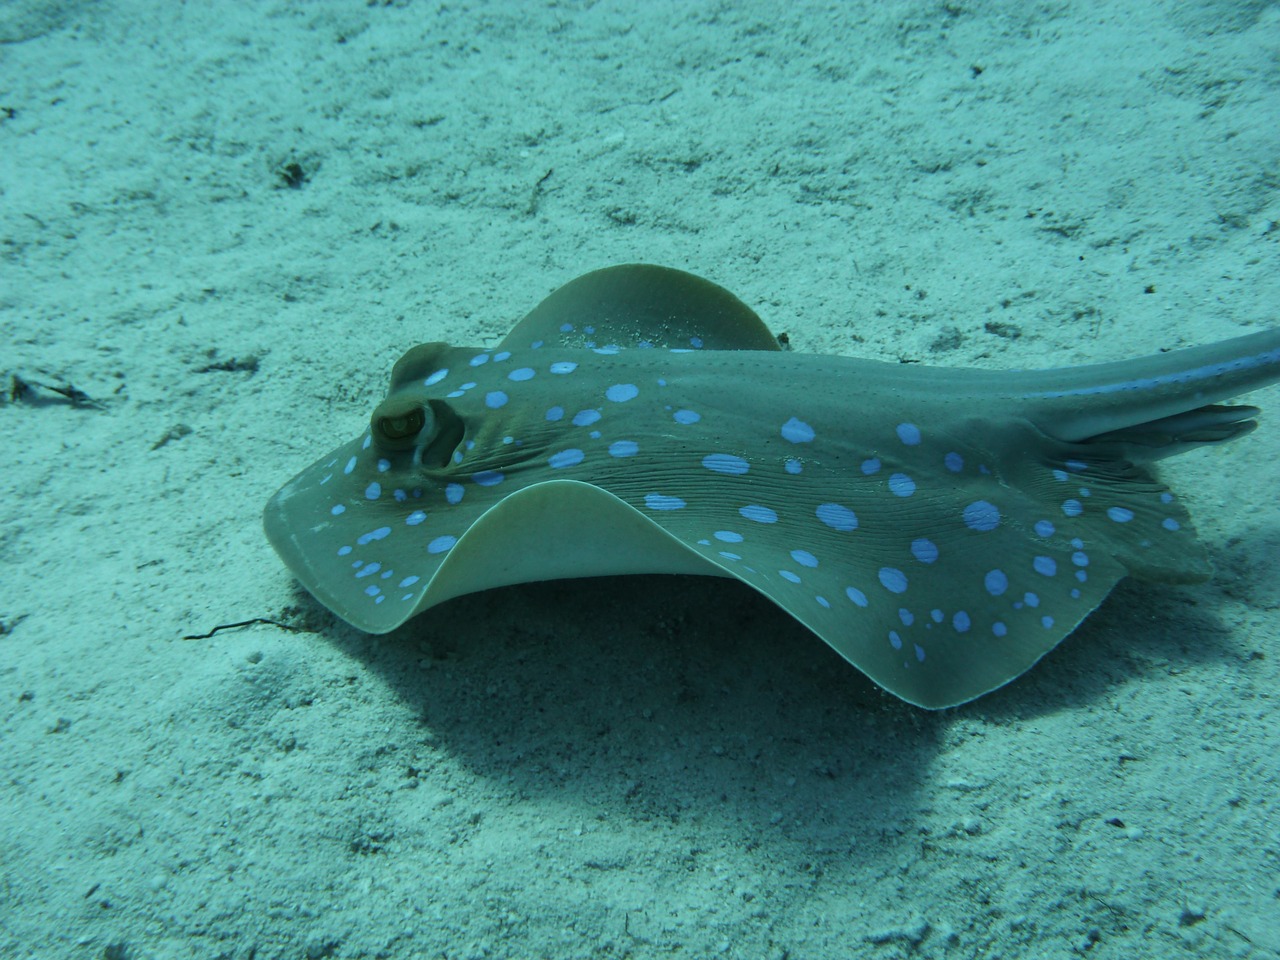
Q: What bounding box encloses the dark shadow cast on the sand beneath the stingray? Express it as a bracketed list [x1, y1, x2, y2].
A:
[282, 547, 1249, 858]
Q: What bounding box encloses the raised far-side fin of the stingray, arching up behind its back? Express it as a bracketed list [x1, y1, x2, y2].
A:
[502, 264, 781, 351]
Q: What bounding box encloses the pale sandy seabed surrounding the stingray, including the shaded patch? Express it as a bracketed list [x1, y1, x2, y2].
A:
[0, 0, 1280, 960]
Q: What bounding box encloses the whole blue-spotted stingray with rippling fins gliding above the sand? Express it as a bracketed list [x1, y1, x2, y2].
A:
[264, 264, 1280, 708]
